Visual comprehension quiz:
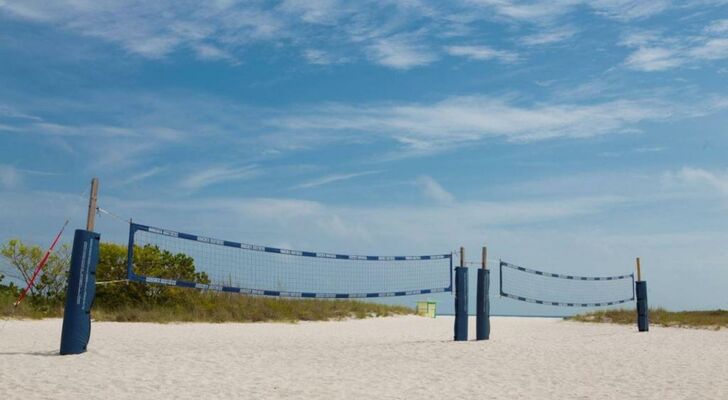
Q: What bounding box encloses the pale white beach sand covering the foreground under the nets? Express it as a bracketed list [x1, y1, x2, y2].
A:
[0, 317, 728, 400]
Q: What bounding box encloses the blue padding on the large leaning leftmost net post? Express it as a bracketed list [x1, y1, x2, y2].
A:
[61, 229, 101, 355]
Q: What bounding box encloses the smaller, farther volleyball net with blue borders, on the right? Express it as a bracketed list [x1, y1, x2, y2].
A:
[500, 262, 634, 307]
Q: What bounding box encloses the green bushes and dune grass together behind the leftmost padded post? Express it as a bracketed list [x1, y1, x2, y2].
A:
[0, 239, 413, 323]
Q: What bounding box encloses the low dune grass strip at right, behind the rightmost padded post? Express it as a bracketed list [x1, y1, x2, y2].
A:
[568, 308, 728, 330]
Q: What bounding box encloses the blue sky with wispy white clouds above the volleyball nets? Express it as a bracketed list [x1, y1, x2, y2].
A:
[0, 0, 728, 314]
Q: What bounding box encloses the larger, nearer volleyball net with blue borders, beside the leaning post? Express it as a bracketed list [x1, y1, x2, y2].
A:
[127, 223, 452, 298]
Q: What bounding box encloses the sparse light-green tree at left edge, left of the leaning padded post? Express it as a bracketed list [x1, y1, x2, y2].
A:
[0, 239, 71, 301]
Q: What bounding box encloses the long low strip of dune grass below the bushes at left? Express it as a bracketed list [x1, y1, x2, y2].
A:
[0, 291, 414, 323]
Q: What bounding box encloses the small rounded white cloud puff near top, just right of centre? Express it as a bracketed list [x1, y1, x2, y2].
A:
[369, 35, 437, 70]
